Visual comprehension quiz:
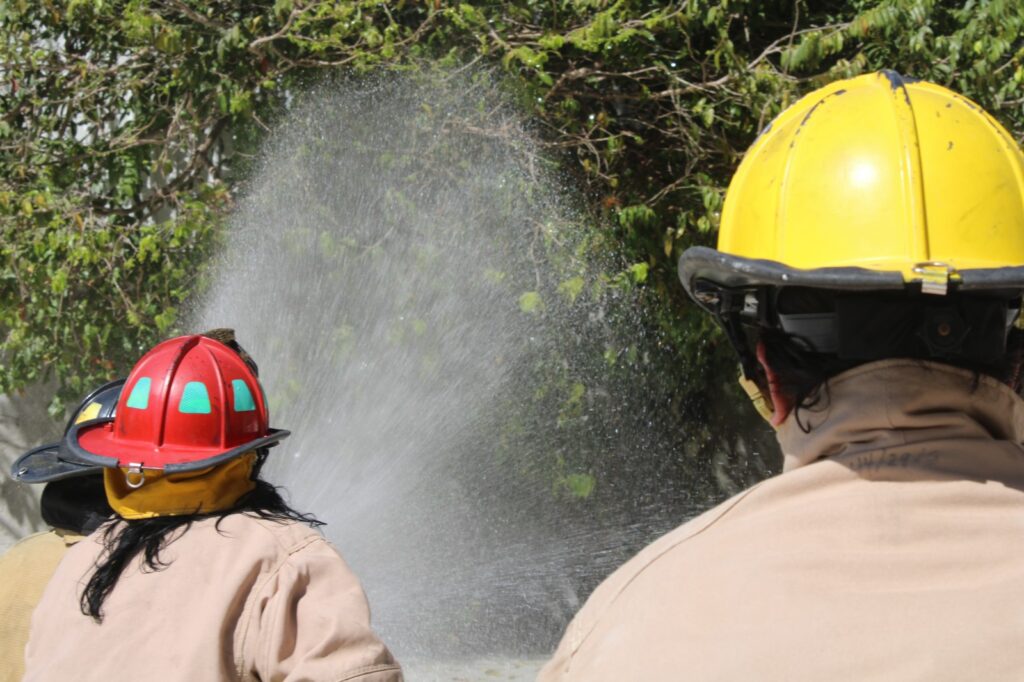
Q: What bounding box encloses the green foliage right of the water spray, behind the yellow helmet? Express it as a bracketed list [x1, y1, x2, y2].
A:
[428, 0, 1024, 409]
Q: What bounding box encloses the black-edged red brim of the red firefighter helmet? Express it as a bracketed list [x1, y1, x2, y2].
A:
[60, 418, 291, 473]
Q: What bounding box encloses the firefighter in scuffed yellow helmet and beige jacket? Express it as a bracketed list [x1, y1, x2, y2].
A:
[540, 72, 1024, 682]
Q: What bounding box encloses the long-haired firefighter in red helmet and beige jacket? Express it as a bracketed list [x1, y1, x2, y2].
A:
[25, 335, 402, 682]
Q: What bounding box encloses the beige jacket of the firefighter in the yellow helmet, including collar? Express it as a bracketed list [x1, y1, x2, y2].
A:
[539, 360, 1024, 682]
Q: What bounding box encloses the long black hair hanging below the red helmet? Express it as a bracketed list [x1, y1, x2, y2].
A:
[80, 449, 324, 623]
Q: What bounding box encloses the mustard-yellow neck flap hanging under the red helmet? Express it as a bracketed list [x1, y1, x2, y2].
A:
[103, 453, 256, 519]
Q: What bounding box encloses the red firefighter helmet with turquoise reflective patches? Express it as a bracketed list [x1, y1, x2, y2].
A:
[61, 335, 289, 473]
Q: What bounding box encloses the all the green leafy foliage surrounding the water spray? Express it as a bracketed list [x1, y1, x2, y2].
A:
[0, 0, 1024, 489]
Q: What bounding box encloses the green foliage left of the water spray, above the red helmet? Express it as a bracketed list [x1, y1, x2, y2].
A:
[0, 0, 428, 412]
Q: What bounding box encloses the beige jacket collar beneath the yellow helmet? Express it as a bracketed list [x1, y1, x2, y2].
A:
[778, 359, 1024, 471]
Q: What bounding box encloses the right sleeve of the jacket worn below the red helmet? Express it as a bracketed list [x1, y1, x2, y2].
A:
[240, 539, 403, 682]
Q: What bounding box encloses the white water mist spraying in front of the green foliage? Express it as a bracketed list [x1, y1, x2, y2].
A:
[190, 74, 737, 667]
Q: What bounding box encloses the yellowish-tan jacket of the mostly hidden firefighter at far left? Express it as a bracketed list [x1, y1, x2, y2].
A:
[0, 530, 82, 682]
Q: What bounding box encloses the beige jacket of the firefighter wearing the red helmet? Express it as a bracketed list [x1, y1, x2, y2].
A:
[25, 514, 402, 682]
